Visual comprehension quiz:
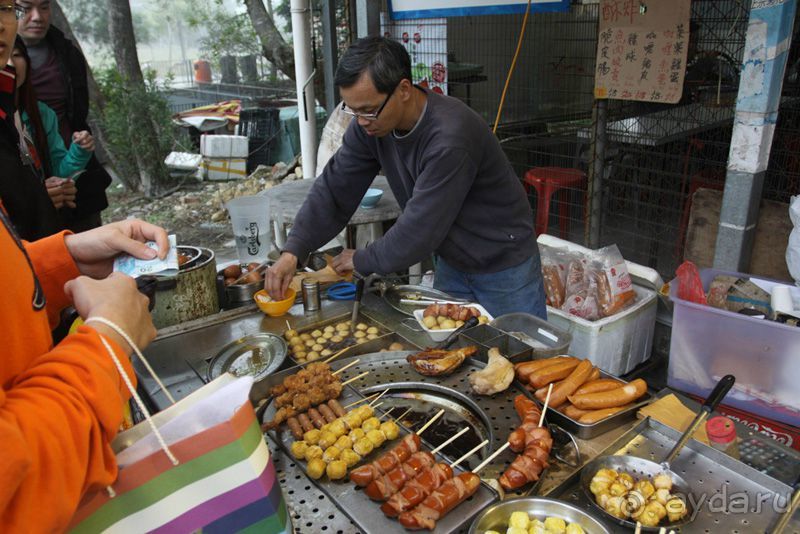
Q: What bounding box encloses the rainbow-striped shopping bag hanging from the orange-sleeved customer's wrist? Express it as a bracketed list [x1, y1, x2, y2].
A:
[69, 374, 292, 534]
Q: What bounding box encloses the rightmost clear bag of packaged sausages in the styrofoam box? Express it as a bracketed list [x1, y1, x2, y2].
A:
[590, 245, 636, 317]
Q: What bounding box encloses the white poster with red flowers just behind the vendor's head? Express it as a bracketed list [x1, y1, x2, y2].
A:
[381, 15, 447, 94]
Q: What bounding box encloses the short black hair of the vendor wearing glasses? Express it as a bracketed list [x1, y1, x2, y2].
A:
[334, 37, 412, 94]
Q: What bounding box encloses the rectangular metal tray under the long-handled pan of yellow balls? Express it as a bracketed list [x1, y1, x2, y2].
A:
[546, 418, 800, 534]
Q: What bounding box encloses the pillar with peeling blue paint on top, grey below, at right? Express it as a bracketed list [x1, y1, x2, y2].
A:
[714, 0, 797, 272]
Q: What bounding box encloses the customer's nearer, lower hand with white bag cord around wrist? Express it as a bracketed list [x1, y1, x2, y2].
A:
[64, 273, 156, 354]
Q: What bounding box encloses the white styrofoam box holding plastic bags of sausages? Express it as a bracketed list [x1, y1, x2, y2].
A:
[537, 234, 662, 376]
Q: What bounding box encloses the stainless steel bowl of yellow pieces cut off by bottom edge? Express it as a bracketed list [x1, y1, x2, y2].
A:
[469, 497, 609, 534]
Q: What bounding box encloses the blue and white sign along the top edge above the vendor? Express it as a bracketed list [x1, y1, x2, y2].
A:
[389, 0, 569, 20]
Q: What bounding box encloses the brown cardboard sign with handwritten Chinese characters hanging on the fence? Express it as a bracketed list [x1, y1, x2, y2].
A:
[594, 0, 691, 104]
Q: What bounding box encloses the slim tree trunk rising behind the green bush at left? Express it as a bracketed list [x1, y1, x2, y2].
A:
[106, 0, 166, 197]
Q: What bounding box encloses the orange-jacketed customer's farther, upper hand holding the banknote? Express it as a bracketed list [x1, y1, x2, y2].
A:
[64, 219, 169, 279]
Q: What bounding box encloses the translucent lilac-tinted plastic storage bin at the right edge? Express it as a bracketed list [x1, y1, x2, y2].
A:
[667, 269, 800, 426]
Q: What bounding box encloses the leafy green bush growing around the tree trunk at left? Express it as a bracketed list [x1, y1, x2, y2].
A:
[96, 68, 186, 193]
